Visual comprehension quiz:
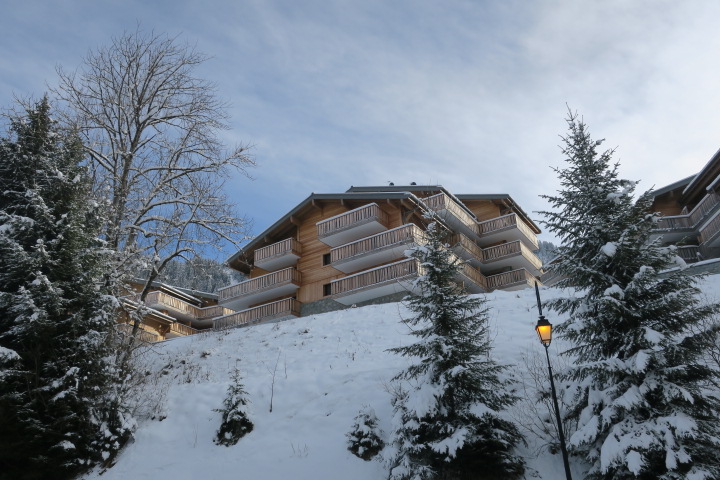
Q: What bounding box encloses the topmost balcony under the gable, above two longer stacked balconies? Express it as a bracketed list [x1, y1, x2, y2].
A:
[316, 203, 388, 247]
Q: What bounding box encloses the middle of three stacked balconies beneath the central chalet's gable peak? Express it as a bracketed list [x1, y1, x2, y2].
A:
[330, 224, 423, 273]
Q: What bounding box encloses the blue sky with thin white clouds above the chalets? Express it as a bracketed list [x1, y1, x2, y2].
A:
[0, 0, 720, 253]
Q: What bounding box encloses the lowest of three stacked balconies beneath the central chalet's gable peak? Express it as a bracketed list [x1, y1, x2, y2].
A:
[330, 258, 421, 305]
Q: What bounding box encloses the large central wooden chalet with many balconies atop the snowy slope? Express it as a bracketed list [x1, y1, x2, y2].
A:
[213, 185, 541, 329]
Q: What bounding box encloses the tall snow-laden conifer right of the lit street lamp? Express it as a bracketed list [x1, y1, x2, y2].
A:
[542, 110, 720, 480]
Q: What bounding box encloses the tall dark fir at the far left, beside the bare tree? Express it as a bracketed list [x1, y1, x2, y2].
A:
[0, 99, 129, 480]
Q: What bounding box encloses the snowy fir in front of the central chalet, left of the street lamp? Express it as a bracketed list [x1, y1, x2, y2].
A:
[387, 223, 524, 480]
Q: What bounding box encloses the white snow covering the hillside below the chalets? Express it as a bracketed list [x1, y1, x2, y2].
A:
[87, 275, 720, 480]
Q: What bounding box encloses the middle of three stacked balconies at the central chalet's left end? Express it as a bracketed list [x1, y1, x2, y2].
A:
[218, 267, 301, 310]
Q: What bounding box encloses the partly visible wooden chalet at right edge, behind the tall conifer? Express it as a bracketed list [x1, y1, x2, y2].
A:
[652, 150, 720, 263]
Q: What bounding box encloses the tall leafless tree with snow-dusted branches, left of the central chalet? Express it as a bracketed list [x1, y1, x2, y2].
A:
[54, 30, 254, 328]
